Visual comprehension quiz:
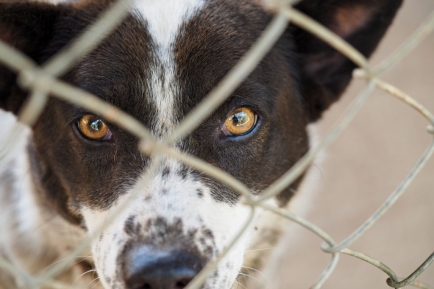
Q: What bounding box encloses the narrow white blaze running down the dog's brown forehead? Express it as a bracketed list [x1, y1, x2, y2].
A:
[134, 0, 205, 135]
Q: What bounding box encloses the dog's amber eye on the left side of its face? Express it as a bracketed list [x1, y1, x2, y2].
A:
[78, 114, 112, 140]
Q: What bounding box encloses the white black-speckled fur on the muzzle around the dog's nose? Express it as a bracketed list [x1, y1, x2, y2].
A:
[82, 162, 251, 288]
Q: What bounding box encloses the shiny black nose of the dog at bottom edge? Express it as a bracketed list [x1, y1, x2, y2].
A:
[124, 246, 204, 289]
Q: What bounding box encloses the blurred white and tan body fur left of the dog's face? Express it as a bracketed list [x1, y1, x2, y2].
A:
[0, 110, 90, 288]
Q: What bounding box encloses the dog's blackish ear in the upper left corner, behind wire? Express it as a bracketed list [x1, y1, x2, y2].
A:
[0, 2, 62, 113]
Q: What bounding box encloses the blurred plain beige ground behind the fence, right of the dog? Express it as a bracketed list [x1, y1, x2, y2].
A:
[265, 0, 434, 289]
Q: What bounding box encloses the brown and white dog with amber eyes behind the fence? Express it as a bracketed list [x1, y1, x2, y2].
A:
[0, 0, 402, 289]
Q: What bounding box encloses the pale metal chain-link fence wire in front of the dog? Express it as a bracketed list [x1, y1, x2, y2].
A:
[0, 0, 434, 289]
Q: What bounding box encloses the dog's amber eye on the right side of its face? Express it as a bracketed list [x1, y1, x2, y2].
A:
[222, 107, 258, 135]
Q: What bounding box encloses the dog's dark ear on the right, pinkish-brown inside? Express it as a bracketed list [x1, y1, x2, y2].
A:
[291, 0, 402, 121]
